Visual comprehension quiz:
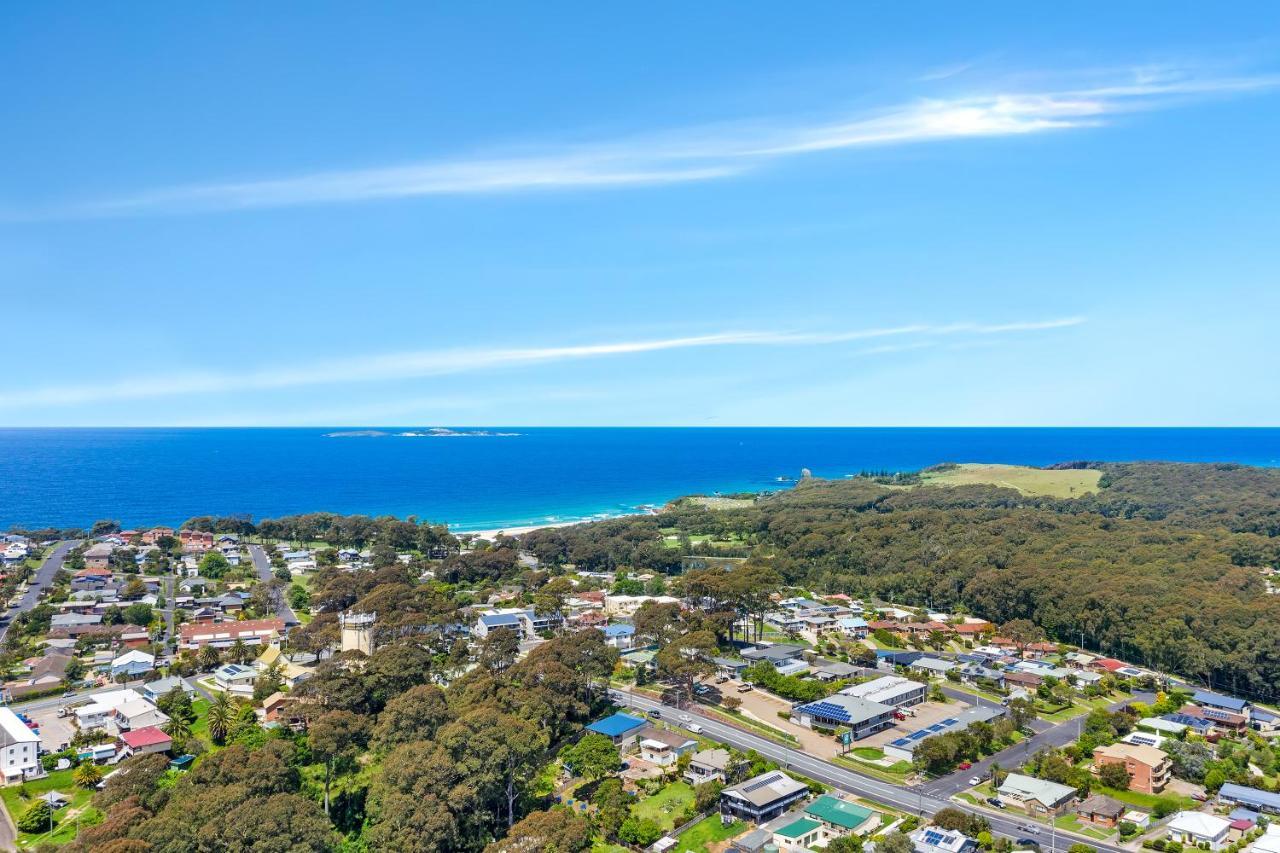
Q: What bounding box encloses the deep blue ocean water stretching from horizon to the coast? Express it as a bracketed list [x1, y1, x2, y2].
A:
[0, 427, 1280, 529]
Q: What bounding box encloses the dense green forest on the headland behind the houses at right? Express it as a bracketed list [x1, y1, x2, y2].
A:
[525, 462, 1280, 699]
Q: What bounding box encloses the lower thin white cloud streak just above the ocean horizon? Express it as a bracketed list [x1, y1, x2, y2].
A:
[0, 316, 1084, 411]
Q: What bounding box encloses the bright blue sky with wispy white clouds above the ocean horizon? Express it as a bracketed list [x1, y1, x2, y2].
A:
[0, 3, 1280, 425]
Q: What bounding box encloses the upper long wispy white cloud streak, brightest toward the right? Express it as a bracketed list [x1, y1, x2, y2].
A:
[15, 67, 1280, 220]
